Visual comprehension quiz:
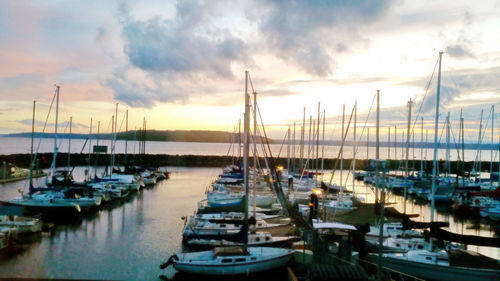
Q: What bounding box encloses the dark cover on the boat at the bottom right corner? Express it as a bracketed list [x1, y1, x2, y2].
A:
[448, 250, 500, 270]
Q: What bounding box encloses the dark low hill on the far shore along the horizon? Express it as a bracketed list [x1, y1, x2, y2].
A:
[3, 130, 274, 143]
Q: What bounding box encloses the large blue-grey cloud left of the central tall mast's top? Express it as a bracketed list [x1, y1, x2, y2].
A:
[107, 1, 252, 108]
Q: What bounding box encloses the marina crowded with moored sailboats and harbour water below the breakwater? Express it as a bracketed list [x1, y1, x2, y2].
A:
[0, 68, 500, 280]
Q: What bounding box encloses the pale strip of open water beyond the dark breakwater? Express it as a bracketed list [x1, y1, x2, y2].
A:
[0, 137, 498, 161]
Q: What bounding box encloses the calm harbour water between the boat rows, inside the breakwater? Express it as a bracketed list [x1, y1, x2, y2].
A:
[0, 167, 500, 280]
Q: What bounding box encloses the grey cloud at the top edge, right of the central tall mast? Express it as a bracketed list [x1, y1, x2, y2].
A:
[259, 0, 393, 76]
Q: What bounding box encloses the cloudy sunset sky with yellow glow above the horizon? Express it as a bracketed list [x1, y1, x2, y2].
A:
[0, 0, 500, 143]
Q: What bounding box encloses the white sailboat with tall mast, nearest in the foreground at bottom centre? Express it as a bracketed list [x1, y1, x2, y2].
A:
[160, 71, 294, 275]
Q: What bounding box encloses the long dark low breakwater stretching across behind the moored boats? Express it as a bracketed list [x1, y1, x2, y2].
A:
[0, 153, 498, 174]
